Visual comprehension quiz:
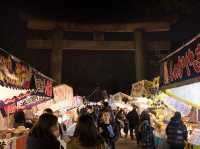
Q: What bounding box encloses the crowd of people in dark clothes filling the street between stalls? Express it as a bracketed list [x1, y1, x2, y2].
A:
[11, 102, 187, 149]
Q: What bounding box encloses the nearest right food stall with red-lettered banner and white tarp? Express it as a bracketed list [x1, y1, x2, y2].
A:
[161, 34, 200, 148]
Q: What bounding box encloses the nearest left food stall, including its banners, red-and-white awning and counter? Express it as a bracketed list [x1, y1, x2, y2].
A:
[0, 49, 53, 149]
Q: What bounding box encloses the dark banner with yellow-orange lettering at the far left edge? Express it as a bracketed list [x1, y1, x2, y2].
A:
[0, 50, 32, 89]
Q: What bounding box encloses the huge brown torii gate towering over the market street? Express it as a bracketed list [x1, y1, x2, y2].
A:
[26, 17, 174, 83]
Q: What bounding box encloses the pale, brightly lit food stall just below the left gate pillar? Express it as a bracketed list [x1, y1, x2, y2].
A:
[36, 84, 83, 138]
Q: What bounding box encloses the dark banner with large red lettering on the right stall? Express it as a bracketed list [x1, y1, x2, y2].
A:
[161, 34, 200, 85]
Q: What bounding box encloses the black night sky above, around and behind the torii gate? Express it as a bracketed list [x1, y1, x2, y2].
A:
[0, 0, 200, 95]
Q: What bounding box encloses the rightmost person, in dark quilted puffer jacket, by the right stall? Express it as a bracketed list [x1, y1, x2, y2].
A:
[166, 112, 188, 149]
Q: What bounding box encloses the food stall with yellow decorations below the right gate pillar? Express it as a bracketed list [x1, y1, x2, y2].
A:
[131, 77, 177, 149]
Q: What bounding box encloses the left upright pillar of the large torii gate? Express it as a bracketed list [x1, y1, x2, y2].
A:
[51, 29, 63, 84]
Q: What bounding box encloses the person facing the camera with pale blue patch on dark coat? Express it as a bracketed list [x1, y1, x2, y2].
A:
[99, 111, 120, 149]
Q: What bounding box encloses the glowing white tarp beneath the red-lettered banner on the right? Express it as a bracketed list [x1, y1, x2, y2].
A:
[166, 82, 200, 108]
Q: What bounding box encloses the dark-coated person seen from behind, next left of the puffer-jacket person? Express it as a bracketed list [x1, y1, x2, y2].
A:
[138, 111, 155, 149]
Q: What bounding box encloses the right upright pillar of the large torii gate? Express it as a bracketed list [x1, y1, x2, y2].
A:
[134, 29, 145, 81]
